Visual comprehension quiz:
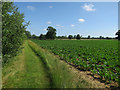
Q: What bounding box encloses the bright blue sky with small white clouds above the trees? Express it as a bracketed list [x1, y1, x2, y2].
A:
[15, 2, 118, 37]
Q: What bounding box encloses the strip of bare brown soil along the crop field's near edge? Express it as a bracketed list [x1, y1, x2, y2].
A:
[51, 52, 120, 89]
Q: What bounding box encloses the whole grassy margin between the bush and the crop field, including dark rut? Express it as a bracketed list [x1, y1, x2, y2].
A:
[2, 41, 115, 88]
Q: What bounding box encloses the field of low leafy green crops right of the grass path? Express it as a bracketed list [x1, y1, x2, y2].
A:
[32, 40, 120, 83]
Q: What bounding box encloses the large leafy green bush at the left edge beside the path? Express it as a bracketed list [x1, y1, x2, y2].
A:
[2, 2, 29, 62]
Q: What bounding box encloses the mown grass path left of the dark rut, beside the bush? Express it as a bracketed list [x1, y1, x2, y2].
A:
[3, 42, 51, 88]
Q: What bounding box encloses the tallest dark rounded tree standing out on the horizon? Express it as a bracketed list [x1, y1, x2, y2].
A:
[46, 26, 56, 39]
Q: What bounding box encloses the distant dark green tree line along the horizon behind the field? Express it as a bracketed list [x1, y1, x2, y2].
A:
[26, 26, 120, 40]
